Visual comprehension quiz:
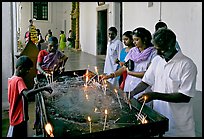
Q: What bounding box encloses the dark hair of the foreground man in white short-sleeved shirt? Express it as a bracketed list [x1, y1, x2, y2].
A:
[152, 28, 176, 50]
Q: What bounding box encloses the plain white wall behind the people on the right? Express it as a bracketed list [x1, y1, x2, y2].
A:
[123, 2, 202, 90]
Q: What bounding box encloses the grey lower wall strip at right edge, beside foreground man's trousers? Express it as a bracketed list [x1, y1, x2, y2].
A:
[192, 91, 202, 137]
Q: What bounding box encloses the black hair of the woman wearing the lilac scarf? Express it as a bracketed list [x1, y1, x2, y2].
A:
[133, 27, 152, 47]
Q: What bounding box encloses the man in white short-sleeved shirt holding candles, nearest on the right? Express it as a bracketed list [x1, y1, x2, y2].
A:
[131, 28, 197, 137]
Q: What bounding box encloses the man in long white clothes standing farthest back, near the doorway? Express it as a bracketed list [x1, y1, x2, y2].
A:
[104, 27, 123, 86]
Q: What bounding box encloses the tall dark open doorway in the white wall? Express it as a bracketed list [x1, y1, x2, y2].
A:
[97, 9, 107, 55]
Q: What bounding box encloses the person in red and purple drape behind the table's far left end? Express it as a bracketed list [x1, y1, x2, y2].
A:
[37, 36, 68, 76]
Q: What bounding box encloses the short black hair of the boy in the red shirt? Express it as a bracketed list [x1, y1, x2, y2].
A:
[16, 55, 33, 68]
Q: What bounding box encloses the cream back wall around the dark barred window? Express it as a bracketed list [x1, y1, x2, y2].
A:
[21, 2, 71, 42]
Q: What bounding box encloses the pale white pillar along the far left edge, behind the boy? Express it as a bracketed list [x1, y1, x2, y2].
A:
[2, 2, 13, 108]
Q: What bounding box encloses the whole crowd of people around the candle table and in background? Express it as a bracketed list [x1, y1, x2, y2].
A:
[8, 21, 197, 137]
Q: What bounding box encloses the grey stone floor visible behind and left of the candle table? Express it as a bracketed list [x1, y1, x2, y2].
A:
[2, 48, 105, 137]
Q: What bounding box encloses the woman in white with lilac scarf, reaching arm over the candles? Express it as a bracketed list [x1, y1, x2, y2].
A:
[102, 27, 156, 105]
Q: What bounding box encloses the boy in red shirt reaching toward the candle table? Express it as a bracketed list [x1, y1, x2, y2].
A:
[7, 56, 52, 137]
